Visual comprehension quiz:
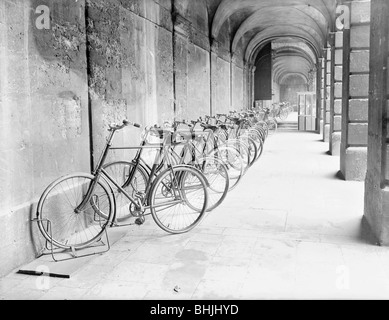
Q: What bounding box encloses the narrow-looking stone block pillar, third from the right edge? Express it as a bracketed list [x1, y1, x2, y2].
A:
[330, 31, 343, 156]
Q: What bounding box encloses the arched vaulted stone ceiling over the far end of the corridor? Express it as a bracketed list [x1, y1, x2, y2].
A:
[204, 0, 338, 81]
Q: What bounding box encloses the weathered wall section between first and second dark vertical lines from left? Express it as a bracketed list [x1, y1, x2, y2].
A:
[86, 0, 174, 162]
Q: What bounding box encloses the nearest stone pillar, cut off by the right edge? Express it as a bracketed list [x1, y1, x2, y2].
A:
[365, 0, 389, 245]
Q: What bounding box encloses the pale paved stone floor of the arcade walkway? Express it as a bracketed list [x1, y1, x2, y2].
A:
[0, 127, 389, 300]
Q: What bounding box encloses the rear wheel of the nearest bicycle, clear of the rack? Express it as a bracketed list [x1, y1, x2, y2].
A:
[149, 166, 208, 234]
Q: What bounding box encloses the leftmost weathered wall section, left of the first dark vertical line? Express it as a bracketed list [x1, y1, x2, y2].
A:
[0, 0, 90, 275]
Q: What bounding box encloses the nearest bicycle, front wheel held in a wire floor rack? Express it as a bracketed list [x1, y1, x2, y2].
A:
[36, 120, 208, 250]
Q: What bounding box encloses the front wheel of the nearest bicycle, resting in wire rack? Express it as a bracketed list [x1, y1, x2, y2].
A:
[36, 173, 114, 249]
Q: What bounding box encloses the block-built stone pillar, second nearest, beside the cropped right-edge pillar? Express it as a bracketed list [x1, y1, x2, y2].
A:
[340, 0, 370, 181]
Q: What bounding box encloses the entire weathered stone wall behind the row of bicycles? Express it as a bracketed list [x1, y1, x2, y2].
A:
[0, 0, 247, 276]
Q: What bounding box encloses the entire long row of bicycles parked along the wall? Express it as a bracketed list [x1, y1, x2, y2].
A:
[35, 111, 277, 251]
